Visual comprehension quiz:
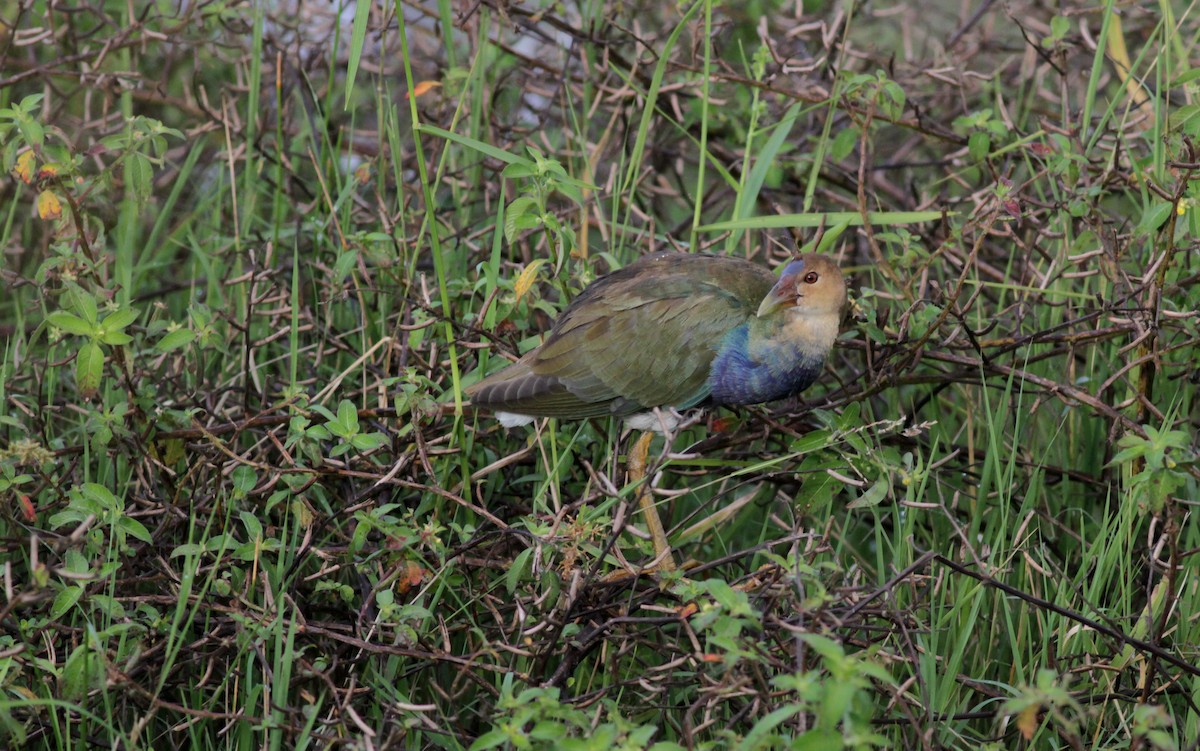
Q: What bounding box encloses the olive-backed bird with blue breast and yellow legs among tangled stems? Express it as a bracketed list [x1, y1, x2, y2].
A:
[466, 251, 846, 571]
